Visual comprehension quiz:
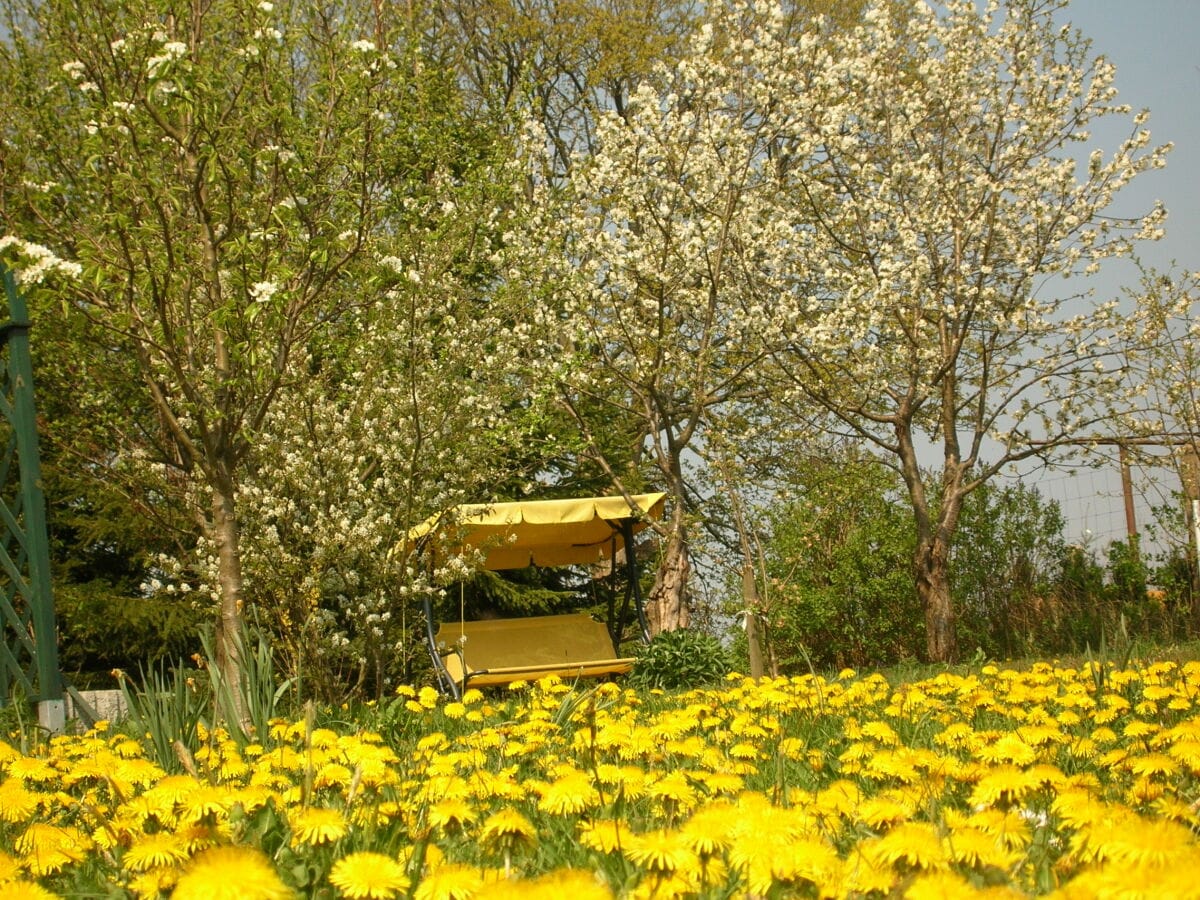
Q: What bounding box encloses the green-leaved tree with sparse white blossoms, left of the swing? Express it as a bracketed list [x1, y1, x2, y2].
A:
[0, 0, 446, 696]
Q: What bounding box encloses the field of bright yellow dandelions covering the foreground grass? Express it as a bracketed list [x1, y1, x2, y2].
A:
[0, 661, 1200, 900]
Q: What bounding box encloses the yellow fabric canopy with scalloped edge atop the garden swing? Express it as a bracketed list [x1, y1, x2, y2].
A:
[407, 493, 666, 570]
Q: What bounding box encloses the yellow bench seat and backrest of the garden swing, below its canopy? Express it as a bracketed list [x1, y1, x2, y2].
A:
[437, 613, 636, 688]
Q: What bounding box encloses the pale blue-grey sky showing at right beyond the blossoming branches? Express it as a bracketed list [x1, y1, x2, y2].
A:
[1022, 0, 1200, 551]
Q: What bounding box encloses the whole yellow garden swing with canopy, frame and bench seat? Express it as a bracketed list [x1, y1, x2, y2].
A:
[407, 493, 666, 697]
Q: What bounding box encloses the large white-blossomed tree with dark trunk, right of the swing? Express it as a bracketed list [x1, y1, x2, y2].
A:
[763, 0, 1165, 660]
